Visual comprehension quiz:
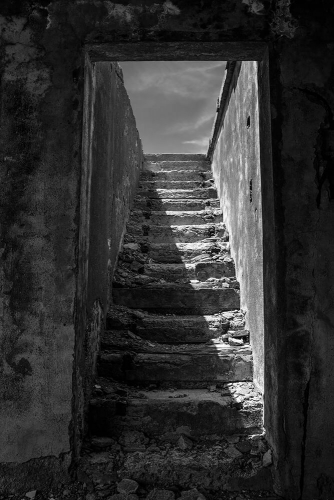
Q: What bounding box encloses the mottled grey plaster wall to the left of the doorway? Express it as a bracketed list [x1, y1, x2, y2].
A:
[0, 10, 79, 472]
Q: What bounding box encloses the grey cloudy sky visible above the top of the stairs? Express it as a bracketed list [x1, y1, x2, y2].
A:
[120, 61, 226, 153]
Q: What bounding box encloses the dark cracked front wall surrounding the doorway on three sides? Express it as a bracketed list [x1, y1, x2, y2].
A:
[0, 0, 334, 500]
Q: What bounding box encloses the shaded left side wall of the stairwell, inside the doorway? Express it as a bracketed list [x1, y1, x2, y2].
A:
[73, 57, 143, 455]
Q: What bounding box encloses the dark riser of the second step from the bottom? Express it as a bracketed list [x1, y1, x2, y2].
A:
[89, 398, 262, 443]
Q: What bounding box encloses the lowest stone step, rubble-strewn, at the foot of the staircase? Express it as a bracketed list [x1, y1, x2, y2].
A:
[79, 432, 274, 494]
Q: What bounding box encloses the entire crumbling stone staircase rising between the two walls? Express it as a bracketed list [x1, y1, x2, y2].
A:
[81, 154, 271, 499]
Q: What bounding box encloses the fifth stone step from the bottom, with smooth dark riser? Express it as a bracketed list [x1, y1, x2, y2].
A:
[112, 283, 240, 315]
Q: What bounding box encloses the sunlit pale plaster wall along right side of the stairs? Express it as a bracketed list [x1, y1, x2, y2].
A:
[212, 61, 264, 392]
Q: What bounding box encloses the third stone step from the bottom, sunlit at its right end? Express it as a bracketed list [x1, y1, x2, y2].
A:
[98, 331, 253, 387]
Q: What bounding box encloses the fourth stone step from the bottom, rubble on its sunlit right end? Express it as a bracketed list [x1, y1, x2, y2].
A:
[106, 305, 245, 343]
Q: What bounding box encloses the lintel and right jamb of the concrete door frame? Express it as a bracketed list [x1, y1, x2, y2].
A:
[84, 41, 285, 488]
